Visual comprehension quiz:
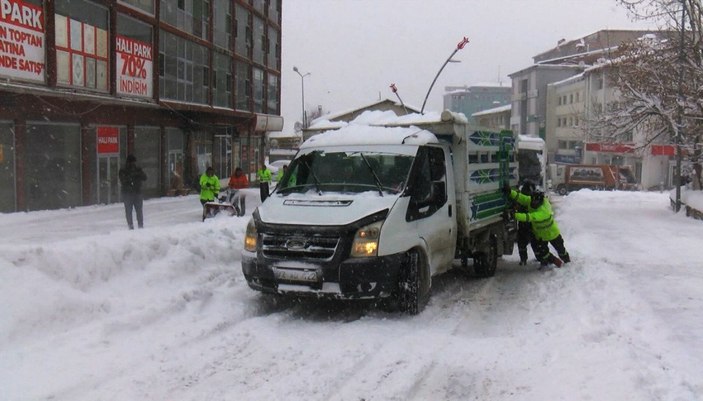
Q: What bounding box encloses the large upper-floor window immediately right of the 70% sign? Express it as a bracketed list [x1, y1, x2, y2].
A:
[159, 31, 209, 104]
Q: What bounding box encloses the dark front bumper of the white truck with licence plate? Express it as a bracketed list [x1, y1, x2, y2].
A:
[242, 252, 405, 299]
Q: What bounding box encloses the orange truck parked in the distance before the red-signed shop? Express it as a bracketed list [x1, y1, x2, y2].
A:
[549, 164, 639, 195]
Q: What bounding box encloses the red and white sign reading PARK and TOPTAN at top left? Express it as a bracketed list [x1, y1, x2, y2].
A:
[0, 0, 46, 82]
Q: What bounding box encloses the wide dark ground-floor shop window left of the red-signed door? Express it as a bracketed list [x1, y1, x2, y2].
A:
[24, 122, 82, 211]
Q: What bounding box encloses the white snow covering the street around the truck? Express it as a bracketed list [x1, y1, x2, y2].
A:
[0, 189, 703, 401]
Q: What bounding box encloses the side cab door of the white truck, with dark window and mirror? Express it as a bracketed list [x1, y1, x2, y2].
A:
[406, 147, 456, 273]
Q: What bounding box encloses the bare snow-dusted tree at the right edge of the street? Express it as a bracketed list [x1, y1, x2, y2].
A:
[592, 0, 703, 158]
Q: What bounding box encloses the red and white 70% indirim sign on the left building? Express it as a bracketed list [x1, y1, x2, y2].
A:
[115, 35, 154, 97]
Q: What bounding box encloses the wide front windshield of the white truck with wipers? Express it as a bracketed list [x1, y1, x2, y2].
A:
[276, 150, 413, 196]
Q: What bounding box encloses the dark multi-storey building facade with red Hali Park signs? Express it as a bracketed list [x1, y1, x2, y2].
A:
[0, 0, 283, 212]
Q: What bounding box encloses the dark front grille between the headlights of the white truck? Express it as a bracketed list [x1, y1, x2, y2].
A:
[261, 234, 339, 260]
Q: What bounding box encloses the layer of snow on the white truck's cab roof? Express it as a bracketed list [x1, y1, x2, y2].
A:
[300, 125, 439, 149]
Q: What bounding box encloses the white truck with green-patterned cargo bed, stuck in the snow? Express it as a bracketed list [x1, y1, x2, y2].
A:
[242, 111, 518, 314]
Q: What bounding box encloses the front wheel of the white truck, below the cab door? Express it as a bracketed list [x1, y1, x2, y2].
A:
[397, 250, 429, 315]
